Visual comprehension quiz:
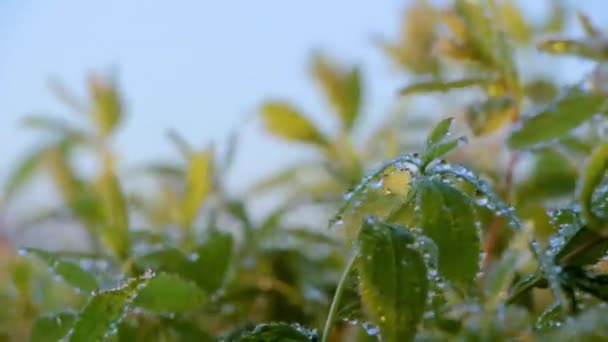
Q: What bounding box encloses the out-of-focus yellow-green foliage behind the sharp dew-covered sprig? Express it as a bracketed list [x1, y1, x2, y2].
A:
[0, 0, 608, 341]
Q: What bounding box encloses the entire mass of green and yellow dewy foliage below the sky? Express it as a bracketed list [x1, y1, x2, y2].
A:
[0, 0, 608, 341]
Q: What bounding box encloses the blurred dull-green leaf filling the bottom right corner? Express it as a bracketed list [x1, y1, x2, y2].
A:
[538, 307, 608, 342]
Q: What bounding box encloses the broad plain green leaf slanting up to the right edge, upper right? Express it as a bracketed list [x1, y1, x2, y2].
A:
[509, 87, 607, 148]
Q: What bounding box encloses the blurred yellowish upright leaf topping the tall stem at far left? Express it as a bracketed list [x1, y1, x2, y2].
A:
[89, 75, 123, 135]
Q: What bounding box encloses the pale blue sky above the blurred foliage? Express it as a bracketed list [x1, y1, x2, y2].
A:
[0, 0, 608, 195]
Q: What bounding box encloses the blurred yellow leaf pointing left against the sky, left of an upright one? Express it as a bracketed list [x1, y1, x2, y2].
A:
[261, 101, 326, 146]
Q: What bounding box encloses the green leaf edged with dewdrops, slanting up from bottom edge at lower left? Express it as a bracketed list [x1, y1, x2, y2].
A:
[66, 274, 153, 342]
